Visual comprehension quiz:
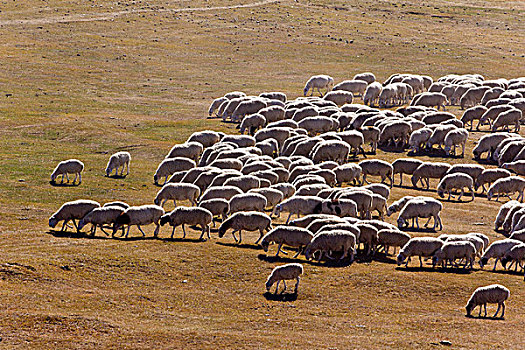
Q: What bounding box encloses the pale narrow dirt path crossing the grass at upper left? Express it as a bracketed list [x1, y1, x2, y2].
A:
[0, 0, 281, 26]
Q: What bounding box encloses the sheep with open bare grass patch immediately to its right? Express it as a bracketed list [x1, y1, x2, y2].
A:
[397, 198, 443, 230]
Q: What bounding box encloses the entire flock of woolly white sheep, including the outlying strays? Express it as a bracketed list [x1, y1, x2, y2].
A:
[49, 73, 525, 316]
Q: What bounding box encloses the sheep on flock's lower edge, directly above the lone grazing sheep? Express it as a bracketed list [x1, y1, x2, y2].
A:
[260, 226, 314, 258]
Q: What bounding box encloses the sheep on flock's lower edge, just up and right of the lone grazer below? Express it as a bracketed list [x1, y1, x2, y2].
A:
[304, 230, 356, 262]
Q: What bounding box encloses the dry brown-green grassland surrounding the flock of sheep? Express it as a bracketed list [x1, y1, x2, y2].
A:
[0, 0, 525, 349]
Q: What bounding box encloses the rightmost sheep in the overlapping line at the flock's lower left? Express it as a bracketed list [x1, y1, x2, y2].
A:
[160, 207, 213, 240]
